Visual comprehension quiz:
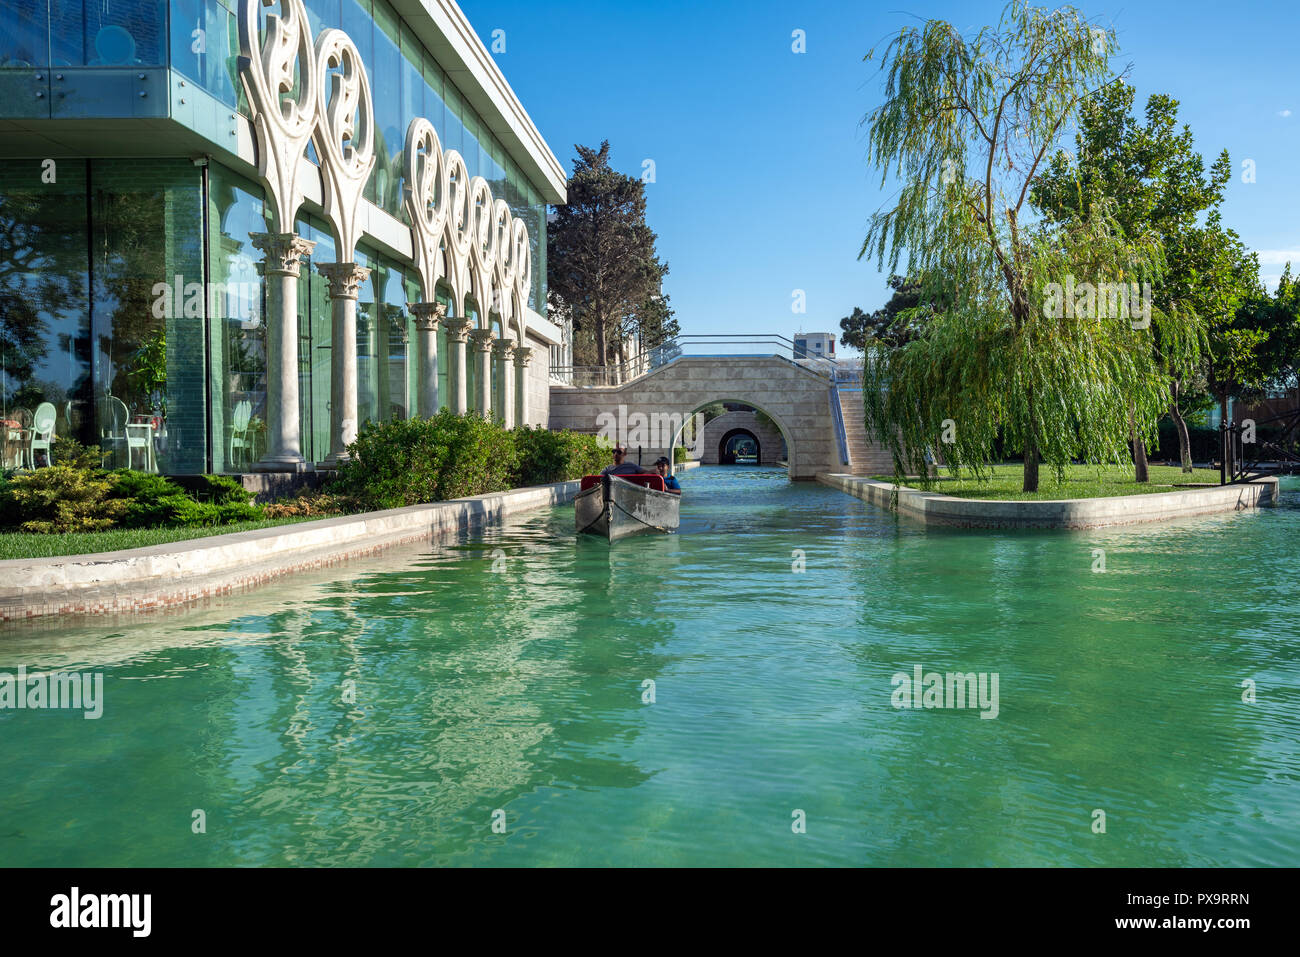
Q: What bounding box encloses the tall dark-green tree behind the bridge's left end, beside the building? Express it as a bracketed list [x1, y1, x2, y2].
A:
[546, 140, 672, 382]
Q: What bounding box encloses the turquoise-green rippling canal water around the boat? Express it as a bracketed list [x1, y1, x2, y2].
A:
[0, 468, 1300, 866]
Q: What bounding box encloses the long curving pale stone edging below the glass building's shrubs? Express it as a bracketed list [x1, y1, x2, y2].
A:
[0, 481, 580, 622]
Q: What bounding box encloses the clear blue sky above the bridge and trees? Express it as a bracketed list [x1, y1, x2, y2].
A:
[462, 0, 1300, 348]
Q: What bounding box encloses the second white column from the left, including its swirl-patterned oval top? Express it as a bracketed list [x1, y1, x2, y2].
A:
[315, 29, 374, 468]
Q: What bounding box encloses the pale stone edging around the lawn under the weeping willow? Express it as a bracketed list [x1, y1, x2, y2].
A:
[818, 473, 1278, 528]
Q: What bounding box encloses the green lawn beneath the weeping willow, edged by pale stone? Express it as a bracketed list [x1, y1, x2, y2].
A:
[872, 463, 1218, 502]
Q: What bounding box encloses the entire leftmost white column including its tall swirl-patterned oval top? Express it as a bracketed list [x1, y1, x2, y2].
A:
[237, 0, 319, 472]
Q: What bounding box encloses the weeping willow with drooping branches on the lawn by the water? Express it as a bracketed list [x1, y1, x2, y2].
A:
[859, 0, 1167, 492]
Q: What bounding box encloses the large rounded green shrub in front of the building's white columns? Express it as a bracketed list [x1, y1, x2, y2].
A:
[334, 411, 515, 510]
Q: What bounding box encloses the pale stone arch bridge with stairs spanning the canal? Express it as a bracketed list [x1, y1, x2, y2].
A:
[550, 355, 893, 480]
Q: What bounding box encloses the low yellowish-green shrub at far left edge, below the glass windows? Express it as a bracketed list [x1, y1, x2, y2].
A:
[0, 465, 127, 534]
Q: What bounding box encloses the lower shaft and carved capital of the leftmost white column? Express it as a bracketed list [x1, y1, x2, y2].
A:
[250, 233, 316, 472]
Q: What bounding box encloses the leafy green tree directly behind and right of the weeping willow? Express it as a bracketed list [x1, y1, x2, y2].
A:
[1030, 79, 1232, 482]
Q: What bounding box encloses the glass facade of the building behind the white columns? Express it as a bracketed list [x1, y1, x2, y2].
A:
[0, 0, 546, 473]
